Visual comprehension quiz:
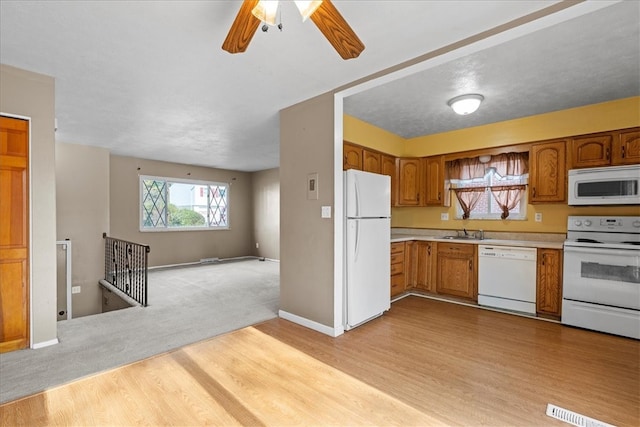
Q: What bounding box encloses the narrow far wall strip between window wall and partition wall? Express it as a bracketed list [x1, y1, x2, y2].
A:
[253, 169, 280, 259]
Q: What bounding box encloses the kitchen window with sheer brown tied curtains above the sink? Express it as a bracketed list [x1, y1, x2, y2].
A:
[447, 153, 528, 219]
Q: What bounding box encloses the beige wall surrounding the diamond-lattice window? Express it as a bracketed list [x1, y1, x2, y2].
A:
[109, 155, 255, 266]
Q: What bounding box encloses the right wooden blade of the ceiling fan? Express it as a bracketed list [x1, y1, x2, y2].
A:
[310, 0, 364, 59]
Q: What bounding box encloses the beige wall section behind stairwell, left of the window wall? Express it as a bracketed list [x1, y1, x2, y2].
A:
[56, 142, 109, 318]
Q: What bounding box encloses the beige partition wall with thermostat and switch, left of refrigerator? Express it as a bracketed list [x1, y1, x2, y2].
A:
[280, 94, 336, 328]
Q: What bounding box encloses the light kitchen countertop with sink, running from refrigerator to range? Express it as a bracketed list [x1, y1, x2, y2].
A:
[391, 230, 565, 249]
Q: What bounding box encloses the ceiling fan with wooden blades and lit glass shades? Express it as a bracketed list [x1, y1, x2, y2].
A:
[222, 0, 364, 59]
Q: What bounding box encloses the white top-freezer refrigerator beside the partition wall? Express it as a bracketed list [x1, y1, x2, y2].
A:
[344, 169, 391, 330]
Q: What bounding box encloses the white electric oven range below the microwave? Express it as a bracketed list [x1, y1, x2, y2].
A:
[562, 216, 640, 339]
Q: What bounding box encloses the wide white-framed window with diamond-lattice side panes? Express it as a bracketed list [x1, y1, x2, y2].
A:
[140, 176, 229, 231]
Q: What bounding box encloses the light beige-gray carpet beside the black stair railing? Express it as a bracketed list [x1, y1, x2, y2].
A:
[0, 259, 280, 403]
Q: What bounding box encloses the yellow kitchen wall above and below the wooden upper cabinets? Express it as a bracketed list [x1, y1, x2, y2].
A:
[344, 97, 640, 233]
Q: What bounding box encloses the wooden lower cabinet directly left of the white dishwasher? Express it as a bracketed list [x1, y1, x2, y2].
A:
[436, 243, 477, 301]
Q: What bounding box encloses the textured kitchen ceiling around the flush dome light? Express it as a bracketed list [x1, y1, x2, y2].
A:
[344, 1, 640, 138]
